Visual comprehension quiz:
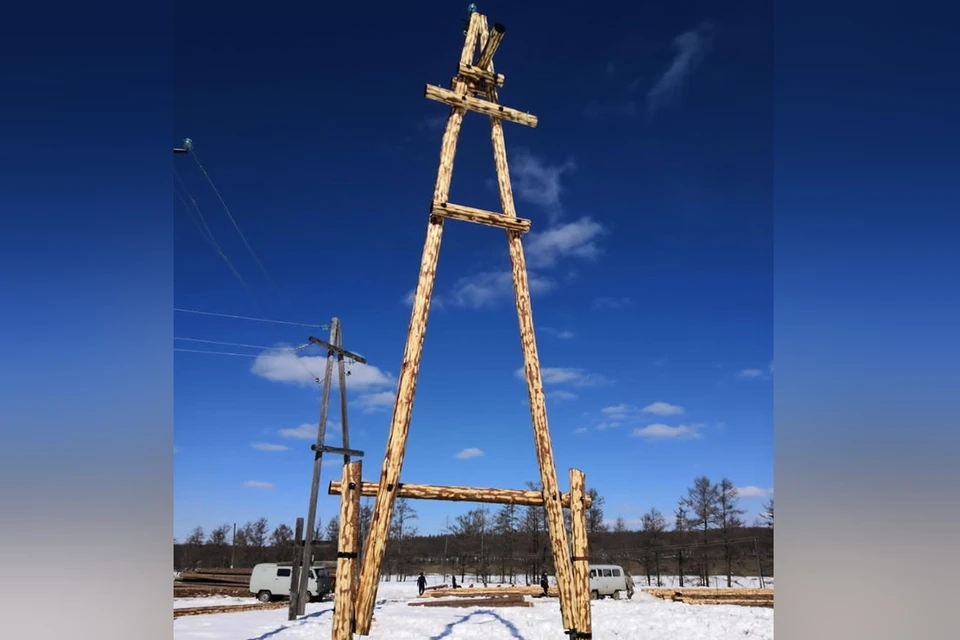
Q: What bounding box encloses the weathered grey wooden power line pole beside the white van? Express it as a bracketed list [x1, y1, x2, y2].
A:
[290, 318, 367, 615]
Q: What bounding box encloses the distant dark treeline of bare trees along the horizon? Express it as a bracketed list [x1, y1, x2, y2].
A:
[174, 477, 773, 584]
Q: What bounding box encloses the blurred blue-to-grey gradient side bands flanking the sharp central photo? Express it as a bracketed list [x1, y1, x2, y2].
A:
[0, 3, 960, 640]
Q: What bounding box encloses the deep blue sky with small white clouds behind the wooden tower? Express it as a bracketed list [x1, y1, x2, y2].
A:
[171, 2, 774, 538]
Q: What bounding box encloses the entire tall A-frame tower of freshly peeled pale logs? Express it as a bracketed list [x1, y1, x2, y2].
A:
[330, 11, 591, 640]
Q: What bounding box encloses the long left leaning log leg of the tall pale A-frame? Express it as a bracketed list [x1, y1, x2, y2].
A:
[356, 12, 480, 636]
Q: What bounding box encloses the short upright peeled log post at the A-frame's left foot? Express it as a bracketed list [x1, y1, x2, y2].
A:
[331, 460, 363, 640]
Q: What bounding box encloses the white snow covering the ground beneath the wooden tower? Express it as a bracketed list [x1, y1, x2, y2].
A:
[173, 576, 773, 640]
